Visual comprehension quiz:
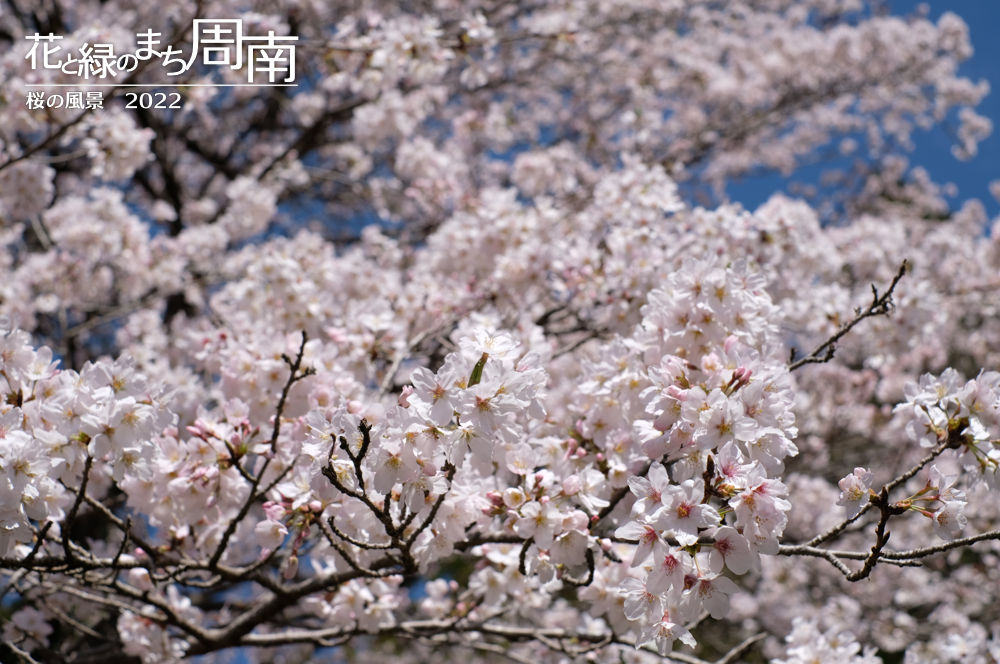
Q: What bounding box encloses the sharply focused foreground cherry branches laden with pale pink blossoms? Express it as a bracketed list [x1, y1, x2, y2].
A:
[0, 255, 1000, 662]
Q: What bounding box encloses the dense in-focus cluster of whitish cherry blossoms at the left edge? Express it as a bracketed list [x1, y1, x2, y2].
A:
[0, 321, 172, 556]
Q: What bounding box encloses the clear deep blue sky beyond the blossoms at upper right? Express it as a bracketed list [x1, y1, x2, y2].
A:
[727, 0, 1000, 218]
